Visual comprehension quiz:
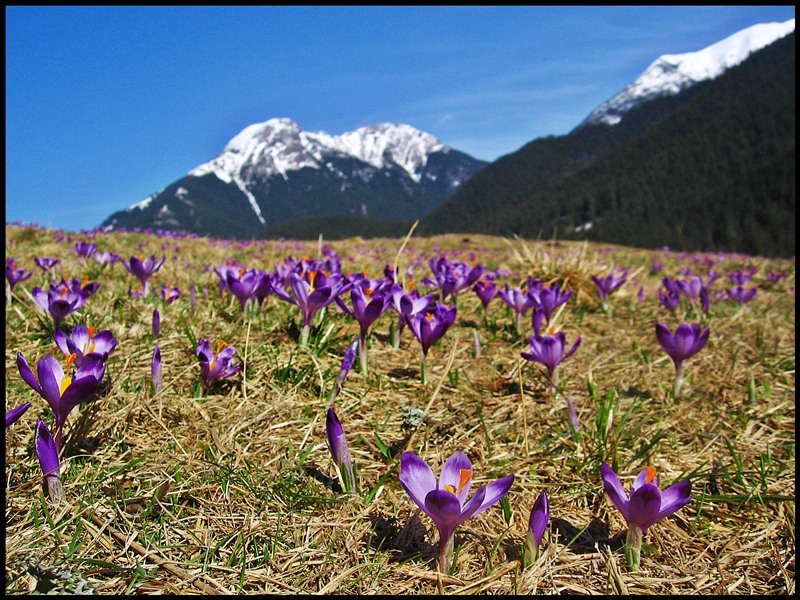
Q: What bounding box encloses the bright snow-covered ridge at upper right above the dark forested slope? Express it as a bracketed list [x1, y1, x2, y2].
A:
[579, 19, 794, 127]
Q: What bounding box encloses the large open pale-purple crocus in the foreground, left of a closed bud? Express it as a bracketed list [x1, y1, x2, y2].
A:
[399, 452, 514, 573]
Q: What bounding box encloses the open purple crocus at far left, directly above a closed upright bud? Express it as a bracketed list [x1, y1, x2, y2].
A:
[17, 352, 106, 448]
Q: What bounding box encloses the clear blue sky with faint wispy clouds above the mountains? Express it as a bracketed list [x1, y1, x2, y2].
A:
[6, 6, 795, 231]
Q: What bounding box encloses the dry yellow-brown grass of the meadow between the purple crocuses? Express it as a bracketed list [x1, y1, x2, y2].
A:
[5, 225, 795, 595]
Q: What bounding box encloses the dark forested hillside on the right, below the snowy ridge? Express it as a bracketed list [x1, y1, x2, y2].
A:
[418, 33, 795, 256]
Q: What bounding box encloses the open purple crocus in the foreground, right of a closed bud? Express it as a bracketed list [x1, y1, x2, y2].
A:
[600, 463, 692, 569]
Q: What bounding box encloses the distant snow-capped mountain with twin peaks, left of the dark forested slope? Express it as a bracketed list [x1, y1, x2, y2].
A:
[103, 118, 486, 237]
